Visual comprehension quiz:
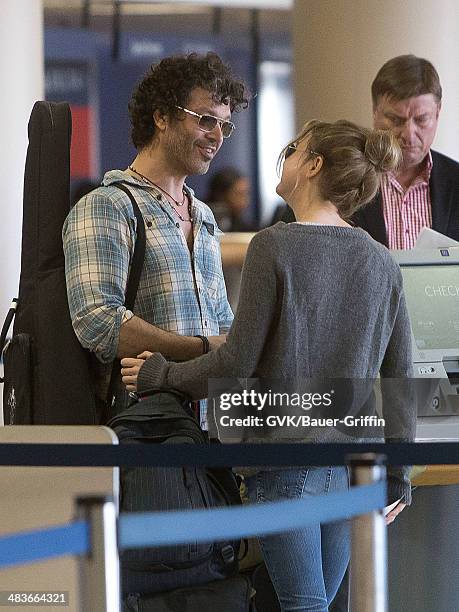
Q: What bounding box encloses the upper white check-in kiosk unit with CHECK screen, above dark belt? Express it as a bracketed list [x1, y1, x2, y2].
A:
[392, 247, 459, 440]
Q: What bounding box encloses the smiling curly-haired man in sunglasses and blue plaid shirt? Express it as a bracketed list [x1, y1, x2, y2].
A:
[63, 53, 248, 418]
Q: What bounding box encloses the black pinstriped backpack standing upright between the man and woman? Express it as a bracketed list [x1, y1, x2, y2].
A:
[108, 390, 241, 600]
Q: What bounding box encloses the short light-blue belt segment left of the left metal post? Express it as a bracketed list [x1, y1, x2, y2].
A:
[0, 521, 89, 568]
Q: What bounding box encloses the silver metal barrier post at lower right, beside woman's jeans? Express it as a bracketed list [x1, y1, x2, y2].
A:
[348, 453, 388, 612]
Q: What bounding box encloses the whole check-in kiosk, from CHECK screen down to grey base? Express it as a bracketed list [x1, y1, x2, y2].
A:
[388, 247, 459, 612]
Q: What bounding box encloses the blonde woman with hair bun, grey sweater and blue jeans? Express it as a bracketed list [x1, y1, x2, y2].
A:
[122, 121, 415, 612]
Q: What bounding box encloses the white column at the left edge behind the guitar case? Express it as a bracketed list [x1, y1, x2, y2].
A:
[0, 0, 44, 420]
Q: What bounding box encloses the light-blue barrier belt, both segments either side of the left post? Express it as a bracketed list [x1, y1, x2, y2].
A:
[0, 481, 386, 569]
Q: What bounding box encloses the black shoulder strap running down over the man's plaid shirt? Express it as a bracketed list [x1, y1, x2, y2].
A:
[102, 183, 146, 416]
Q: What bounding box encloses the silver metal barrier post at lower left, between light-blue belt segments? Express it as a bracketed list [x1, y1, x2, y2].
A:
[77, 496, 121, 612]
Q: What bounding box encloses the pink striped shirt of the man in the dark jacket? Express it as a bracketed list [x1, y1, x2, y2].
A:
[381, 151, 432, 249]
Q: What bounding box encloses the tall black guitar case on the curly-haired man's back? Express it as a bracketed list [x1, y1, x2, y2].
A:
[0, 102, 96, 425]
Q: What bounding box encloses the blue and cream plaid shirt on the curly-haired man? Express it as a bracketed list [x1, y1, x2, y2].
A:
[63, 170, 233, 363]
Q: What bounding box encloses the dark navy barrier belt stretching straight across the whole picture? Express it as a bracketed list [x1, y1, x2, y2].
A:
[0, 442, 459, 467]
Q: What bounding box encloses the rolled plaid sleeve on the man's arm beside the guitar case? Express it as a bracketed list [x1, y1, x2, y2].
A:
[63, 193, 132, 363]
